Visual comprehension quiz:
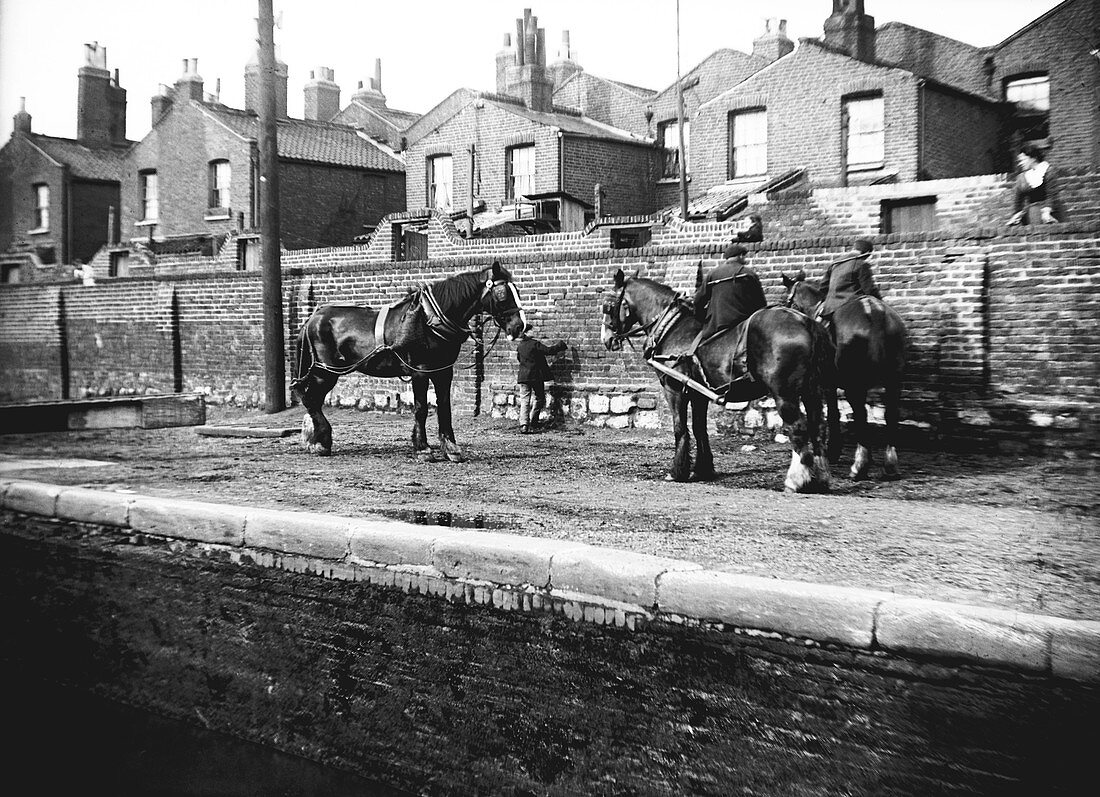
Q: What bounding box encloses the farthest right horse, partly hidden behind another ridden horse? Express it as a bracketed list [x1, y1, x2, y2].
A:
[783, 272, 909, 479]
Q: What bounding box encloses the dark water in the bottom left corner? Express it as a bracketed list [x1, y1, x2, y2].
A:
[3, 680, 408, 797]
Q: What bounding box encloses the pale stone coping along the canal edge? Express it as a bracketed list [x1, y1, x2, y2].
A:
[0, 479, 1100, 683]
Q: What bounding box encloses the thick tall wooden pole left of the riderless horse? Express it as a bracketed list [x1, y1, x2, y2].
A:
[256, 0, 286, 413]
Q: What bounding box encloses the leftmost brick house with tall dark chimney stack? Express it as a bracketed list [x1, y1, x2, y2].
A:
[0, 43, 132, 281]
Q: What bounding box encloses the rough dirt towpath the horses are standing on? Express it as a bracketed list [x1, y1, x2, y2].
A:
[0, 407, 1100, 620]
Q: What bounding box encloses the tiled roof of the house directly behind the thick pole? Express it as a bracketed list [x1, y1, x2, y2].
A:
[199, 102, 405, 171]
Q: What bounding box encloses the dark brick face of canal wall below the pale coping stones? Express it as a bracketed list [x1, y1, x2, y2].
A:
[0, 512, 1100, 795]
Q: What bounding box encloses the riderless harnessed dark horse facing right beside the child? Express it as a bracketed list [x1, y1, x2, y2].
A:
[290, 262, 527, 462]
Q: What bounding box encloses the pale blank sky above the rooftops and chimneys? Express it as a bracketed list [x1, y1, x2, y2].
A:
[0, 0, 1059, 143]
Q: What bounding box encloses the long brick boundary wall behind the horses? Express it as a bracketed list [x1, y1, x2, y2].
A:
[0, 198, 1100, 440]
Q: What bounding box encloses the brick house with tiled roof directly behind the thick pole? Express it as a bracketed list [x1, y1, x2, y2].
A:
[121, 61, 405, 256]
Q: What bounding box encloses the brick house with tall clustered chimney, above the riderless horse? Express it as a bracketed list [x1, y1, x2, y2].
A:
[405, 11, 660, 230]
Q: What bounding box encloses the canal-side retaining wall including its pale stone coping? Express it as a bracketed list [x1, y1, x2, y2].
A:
[0, 474, 1100, 795]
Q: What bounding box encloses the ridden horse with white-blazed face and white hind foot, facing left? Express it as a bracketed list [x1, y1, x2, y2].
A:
[601, 268, 835, 492]
